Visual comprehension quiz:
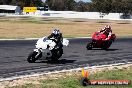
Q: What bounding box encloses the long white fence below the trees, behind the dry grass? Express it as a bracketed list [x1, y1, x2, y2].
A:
[1, 11, 132, 20]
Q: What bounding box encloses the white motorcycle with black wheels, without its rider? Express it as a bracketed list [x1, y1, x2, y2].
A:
[27, 37, 69, 63]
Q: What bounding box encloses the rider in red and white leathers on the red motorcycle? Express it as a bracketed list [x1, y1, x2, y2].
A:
[99, 25, 112, 40]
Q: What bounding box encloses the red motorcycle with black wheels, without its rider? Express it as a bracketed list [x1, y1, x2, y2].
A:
[86, 32, 116, 50]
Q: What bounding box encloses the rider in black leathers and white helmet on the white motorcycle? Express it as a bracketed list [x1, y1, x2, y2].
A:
[48, 29, 63, 47]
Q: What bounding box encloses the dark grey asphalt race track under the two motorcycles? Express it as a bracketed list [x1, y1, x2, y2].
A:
[0, 38, 132, 78]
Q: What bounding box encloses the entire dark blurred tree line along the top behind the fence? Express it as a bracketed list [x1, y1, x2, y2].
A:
[0, 0, 132, 14]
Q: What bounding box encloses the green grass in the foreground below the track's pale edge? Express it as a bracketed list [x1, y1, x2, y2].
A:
[9, 67, 132, 88]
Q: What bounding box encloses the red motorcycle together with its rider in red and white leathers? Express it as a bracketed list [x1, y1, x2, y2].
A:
[86, 25, 116, 50]
